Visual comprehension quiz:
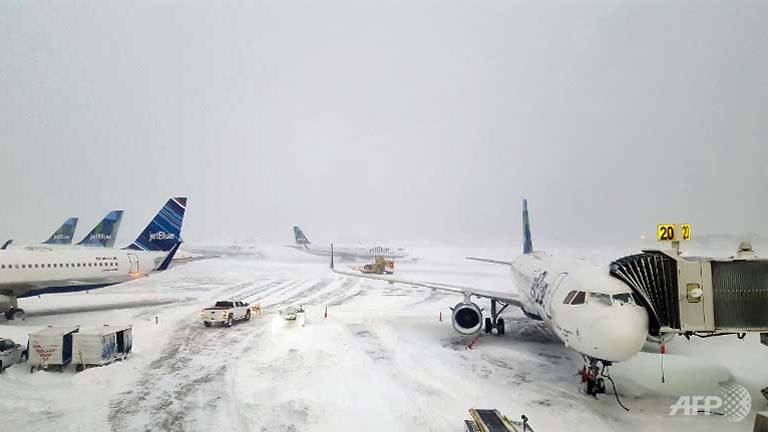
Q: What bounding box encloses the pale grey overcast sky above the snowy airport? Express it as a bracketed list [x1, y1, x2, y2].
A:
[0, 0, 768, 245]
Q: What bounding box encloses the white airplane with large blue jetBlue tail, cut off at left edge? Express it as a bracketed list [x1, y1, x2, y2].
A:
[0, 197, 187, 320]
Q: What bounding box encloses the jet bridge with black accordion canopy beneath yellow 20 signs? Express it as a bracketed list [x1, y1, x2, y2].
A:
[610, 244, 768, 337]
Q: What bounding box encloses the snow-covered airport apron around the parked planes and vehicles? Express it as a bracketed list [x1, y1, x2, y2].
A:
[0, 247, 768, 432]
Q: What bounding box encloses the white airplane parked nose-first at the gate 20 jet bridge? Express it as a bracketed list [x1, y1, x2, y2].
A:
[331, 200, 648, 396]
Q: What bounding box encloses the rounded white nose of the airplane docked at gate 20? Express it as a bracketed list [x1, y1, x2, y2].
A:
[592, 307, 648, 361]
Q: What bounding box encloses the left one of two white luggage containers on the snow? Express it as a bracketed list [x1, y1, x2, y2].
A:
[27, 327, 79, 372]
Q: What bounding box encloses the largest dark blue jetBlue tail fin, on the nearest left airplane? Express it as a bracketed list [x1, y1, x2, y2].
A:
[126, 197, 187, 252]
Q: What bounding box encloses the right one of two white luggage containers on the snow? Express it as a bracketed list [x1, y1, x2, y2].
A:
[74, 325, 133, 371]
